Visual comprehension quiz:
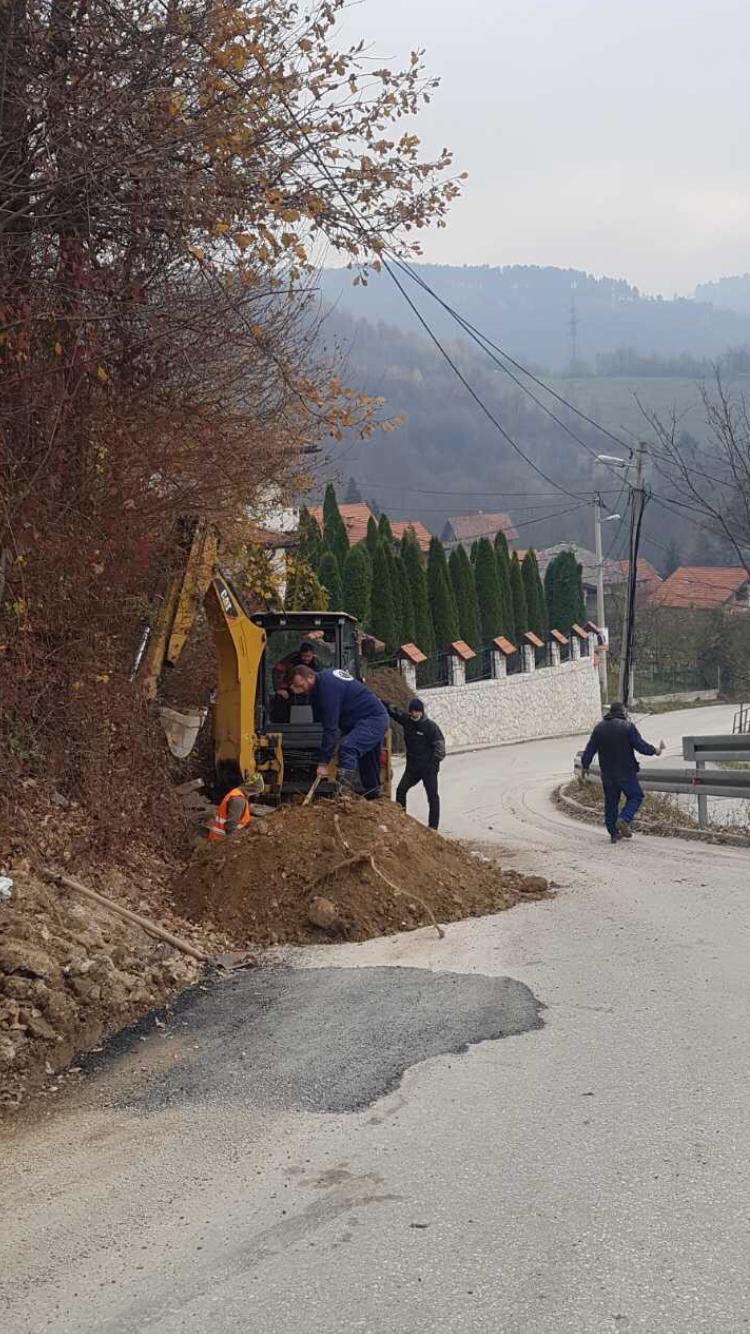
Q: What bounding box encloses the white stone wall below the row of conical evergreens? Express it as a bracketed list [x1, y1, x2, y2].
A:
[419, 658, 602, 751]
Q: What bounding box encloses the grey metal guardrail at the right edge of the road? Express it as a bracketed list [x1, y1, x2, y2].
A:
[574, 735, 750, 828]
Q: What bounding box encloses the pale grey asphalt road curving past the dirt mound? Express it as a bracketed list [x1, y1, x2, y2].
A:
[0, 710, 750, 1334]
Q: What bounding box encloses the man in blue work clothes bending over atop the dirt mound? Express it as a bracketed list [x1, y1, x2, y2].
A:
[290, 667, 388, 798]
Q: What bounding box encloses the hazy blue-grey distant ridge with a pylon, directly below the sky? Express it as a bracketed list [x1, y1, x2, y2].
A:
[320, 264, 750, 371]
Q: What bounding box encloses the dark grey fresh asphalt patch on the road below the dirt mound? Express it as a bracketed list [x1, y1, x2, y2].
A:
[89, 967, 543, 1114]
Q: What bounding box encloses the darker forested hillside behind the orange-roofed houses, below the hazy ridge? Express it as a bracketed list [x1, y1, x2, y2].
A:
[320, 309, 750, 567]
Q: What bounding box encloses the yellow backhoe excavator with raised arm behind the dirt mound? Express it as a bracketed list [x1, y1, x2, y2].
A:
[132, 520, 391, 804]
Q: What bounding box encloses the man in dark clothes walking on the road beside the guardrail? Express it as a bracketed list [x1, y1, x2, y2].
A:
[581, 704, 665, 843]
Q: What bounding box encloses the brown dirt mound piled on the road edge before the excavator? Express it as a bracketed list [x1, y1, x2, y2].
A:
[175, 799, 547, 947]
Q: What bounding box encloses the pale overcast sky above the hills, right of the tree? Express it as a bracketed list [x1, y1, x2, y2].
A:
[347, 0, 750, 295]
